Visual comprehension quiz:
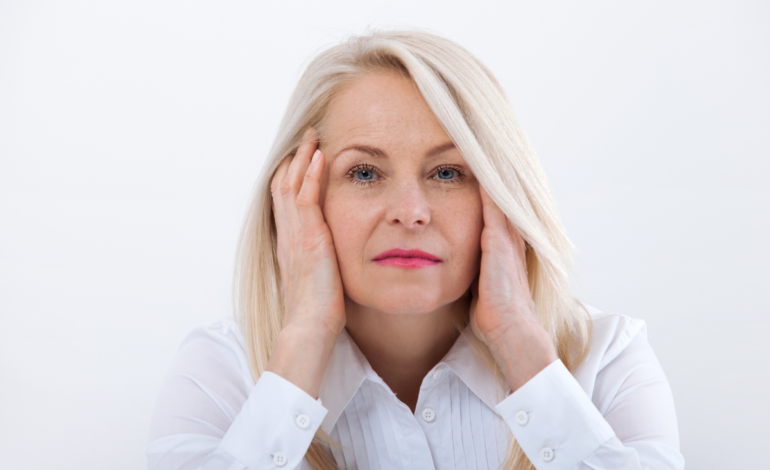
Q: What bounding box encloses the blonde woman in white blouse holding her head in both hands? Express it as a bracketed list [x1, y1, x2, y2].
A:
[147, 31, 684, 469]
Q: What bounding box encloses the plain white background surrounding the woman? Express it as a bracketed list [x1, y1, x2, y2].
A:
[0, 0, 770, 470]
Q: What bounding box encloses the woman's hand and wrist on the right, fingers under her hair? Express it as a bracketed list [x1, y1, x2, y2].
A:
[470, 186, 559, 391]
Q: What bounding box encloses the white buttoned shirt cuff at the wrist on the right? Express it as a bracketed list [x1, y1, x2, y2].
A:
[495, 359, 615, 470]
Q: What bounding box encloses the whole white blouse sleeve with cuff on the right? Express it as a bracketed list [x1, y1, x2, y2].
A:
[496, 326, 684, 470]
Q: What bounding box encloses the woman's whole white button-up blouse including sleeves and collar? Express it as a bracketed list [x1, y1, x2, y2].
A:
[147, 307, 684, 470]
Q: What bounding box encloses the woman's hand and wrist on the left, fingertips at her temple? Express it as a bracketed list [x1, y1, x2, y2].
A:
[266, 128, 345, 396]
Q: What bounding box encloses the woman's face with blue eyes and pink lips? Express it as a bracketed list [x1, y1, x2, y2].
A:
[320, 73, 483, 313]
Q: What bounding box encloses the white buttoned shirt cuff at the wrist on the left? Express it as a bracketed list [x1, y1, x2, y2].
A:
[219, 372, 328, 468]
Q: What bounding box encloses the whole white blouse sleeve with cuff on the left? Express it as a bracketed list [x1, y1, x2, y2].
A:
[147, 322, 327, 470]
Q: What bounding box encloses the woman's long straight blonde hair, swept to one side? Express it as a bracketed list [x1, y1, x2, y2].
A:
[233, 30, 591, 470]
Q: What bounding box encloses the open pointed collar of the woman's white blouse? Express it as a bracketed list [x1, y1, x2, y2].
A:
[318, 325, 509, 434]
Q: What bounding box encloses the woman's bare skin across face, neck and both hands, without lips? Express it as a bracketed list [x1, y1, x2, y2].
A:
[266, 72, 558, 412]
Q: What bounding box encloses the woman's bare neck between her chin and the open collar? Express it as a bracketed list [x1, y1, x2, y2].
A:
[345, 296, 470, 412]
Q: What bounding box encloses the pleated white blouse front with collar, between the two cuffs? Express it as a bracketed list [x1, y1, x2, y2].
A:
[319, 329, 510, 470]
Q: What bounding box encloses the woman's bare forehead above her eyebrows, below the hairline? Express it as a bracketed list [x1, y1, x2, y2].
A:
[324, 72, 449, 146]
